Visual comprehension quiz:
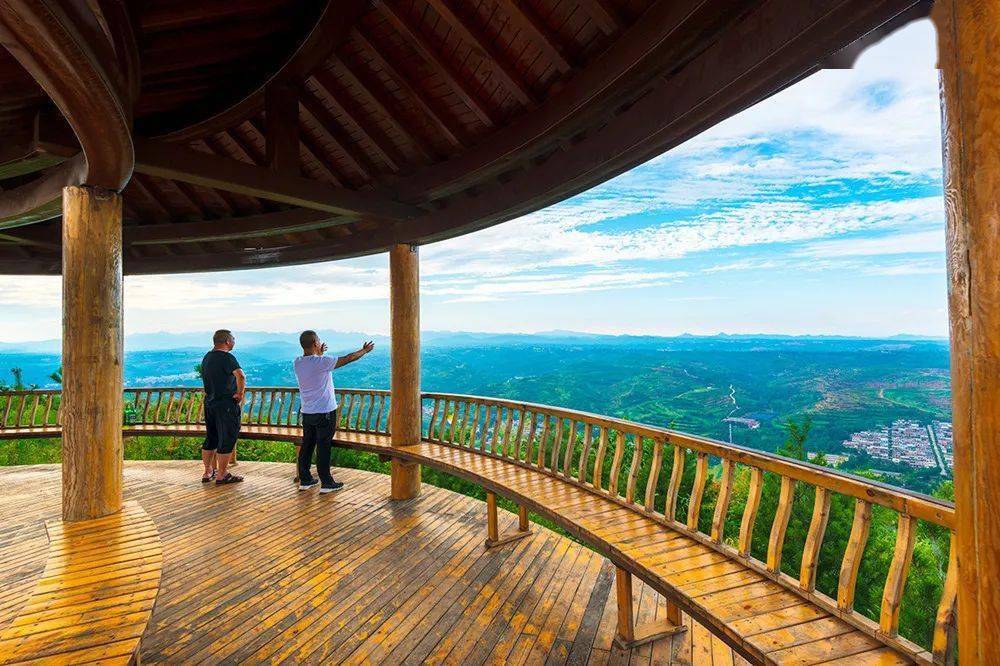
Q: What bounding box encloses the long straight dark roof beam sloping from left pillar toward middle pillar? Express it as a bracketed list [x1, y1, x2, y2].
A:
[136, 139, 424, 220]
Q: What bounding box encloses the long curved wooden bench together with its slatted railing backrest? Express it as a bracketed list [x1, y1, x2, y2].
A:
[0, 389, 957, 666]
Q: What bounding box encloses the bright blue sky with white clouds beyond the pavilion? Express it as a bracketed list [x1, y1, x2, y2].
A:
[0, 21, 947, 341]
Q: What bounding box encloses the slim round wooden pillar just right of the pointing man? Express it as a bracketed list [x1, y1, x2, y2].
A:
[389, 245, 422, 499]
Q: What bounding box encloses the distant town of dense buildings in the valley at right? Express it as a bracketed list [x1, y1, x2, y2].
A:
[844, 419, 954, 476]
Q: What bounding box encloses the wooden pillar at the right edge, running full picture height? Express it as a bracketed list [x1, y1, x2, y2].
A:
[934, 0, 1000, 664]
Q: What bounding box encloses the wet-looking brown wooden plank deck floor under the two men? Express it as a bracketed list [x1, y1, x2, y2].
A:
[0, 461, 746, 665]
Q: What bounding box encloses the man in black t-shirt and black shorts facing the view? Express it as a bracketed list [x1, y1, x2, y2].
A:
[201, 329, 246, 485]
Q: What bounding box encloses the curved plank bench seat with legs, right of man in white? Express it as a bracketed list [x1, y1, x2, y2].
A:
[337, 433, 914, 665]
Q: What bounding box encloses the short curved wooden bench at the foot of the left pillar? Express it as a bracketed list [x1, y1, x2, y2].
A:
[0, 502, 163, 664]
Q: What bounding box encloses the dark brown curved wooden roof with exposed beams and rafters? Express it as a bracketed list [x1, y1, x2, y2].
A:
[0, 0, 927, 273]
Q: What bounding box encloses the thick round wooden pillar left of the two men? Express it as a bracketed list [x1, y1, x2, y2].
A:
[62, 186, 123, 520]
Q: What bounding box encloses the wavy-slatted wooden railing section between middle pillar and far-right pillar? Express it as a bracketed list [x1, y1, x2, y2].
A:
[423, 393, 957, 661]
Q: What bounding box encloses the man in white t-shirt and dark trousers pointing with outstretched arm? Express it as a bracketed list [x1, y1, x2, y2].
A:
[295, 331, 375, 493]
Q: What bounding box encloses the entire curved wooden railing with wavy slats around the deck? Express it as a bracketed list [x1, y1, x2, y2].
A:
[0, 387, 957, 662]
